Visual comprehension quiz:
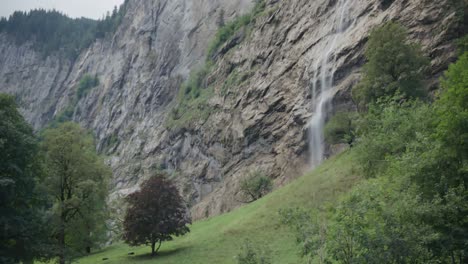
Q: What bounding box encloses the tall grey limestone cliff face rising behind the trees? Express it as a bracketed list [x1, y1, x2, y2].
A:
[0, 0, 457, 218]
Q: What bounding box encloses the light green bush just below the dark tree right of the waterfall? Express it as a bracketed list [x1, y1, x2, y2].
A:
[356, 99, 434, 177]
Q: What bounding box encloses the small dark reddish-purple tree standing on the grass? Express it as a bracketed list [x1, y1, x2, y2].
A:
[123, 173, 191, 256]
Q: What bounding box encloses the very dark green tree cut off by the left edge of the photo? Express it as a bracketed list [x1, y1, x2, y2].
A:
[0, 94, 48, 263]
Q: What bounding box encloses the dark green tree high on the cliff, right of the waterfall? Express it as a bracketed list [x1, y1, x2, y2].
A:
[353, 22, 429, 107]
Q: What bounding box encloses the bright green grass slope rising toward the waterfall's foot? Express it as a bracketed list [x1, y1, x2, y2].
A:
[77, 151, 359, 264]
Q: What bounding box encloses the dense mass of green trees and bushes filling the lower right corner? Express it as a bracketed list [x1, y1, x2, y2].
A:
[281, 32, 468, 264]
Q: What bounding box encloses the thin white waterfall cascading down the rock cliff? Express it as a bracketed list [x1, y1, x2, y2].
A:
[308, 0, 350, 167]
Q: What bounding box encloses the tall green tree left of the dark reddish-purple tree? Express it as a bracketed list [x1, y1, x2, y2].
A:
[42, 123, 111, 263]
